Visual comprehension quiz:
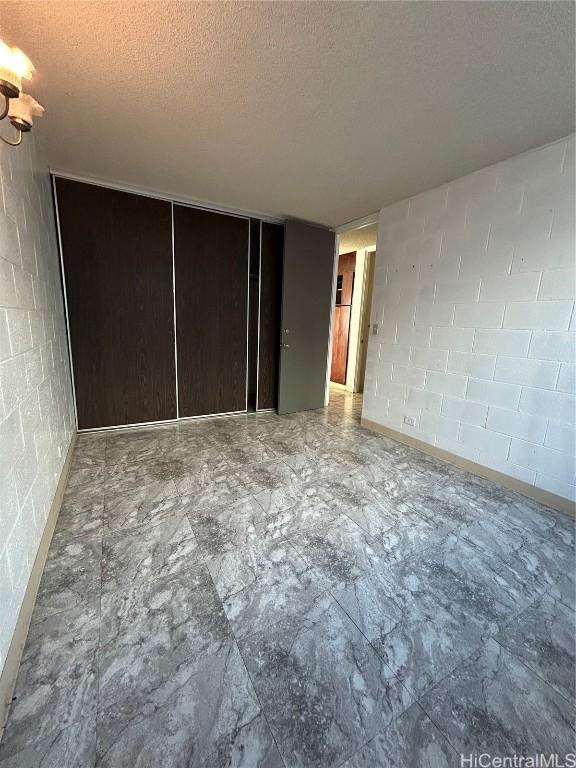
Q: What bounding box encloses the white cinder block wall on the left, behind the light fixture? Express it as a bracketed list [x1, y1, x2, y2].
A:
[0, 134, 75, 671]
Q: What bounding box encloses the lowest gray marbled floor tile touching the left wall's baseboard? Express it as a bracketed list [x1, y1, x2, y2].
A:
[0, 601, 99, 765]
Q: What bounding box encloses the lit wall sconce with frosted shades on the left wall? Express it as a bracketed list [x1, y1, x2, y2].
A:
[0, 40, 44, 147]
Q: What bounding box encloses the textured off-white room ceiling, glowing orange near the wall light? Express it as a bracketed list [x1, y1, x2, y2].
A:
[0, 2, 574, 225]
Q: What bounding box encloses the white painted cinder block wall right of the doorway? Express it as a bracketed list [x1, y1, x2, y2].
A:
[363, 135, 576, 499]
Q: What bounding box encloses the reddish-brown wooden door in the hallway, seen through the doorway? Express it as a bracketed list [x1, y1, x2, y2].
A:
[330, 251, 356, 384]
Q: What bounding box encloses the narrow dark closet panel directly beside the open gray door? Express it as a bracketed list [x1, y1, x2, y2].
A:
[258, 221, 284, 408]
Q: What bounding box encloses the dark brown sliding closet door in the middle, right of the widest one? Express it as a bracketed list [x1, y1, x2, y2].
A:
[174, 205, 249, 417]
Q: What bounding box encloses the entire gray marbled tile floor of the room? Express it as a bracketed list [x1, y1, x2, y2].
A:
[0, 391, 576, 768]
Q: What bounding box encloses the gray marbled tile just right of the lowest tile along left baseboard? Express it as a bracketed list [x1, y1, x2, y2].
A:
[98, 566, 232, 749]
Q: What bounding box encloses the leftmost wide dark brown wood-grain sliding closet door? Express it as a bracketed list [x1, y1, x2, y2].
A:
[56, 179, 176, 429]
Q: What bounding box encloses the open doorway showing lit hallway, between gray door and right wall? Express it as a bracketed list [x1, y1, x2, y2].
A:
[330, 219, 378, 416]
